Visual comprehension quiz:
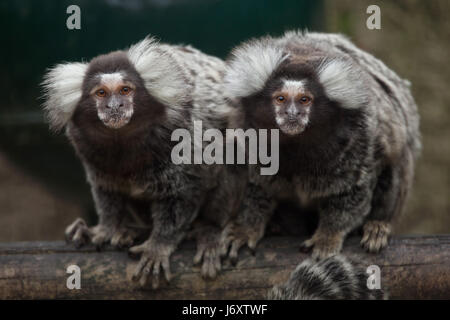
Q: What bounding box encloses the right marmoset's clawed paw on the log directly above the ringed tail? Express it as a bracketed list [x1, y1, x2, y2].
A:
[300, 231, 344, 260]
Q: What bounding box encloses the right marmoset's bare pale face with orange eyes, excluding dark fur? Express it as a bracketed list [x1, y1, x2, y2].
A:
[270, 79, 314, 135]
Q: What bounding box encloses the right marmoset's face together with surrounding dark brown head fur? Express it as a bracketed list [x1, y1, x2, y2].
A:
[241, 65, 342, 140]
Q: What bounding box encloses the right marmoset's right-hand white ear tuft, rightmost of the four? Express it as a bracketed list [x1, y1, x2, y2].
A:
[318, 59, 369, 109]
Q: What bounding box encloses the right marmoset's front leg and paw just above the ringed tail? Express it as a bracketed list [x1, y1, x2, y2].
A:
[300, 186, 371, 259]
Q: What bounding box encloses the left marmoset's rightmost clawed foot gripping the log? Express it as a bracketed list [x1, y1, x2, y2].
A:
[193, 225, 224, 279]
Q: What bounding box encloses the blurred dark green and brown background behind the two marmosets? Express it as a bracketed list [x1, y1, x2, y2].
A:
[0, 0, 450, 241]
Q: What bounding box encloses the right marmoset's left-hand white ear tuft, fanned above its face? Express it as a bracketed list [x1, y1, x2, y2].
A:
[224, 37, 287, 99]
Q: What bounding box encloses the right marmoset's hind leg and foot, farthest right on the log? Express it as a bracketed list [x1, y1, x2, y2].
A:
[361, 153, 414, 252]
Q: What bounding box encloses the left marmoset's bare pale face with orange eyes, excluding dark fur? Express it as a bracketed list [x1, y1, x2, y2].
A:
[90, 72, 136, 129]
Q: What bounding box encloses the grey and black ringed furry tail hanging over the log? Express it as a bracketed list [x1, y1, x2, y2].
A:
[268, 254, 388, 300]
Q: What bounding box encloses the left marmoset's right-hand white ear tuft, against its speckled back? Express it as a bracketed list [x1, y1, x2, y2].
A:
[127, 37, 190, 106]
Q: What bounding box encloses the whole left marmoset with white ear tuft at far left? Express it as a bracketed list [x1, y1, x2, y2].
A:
[43, 38, 242, 287]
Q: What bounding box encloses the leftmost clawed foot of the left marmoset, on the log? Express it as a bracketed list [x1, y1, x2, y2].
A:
[65, 218, 136, 248]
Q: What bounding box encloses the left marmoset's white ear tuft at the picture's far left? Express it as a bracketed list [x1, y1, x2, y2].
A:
[41, 62, 87, 131]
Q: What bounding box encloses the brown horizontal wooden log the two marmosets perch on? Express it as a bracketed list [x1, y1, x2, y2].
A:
[0, 235, 450, 299]
